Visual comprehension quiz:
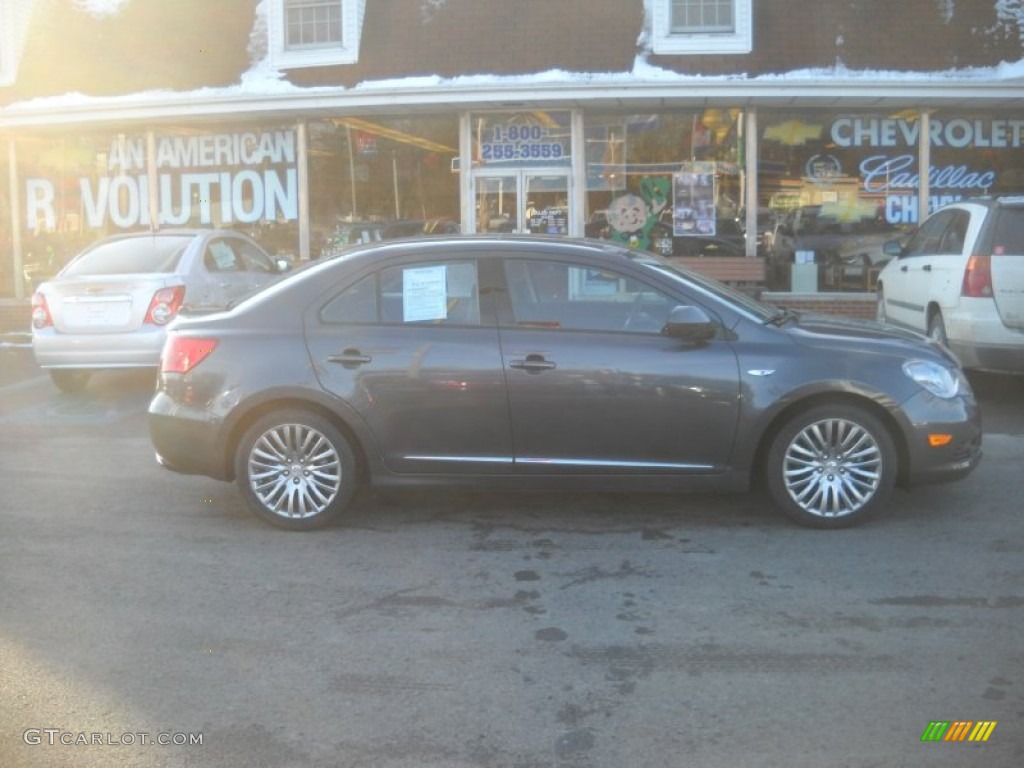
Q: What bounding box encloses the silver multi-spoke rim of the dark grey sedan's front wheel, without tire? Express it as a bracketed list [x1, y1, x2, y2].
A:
[782, 419, 884, 518]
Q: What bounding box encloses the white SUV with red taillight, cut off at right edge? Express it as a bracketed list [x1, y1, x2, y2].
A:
[878, 197, 1024, 374]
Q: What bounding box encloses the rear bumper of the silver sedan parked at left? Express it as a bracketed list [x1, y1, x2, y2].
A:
[32, 326, 167, 368]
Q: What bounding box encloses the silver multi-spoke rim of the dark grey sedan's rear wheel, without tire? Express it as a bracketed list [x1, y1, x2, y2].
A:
[248, 424, 345, 520]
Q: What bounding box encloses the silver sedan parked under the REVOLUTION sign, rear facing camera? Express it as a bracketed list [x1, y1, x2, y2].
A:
[32, 229, 288, 392]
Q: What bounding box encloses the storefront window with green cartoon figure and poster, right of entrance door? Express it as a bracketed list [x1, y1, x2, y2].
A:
[585, 109, 744, 256]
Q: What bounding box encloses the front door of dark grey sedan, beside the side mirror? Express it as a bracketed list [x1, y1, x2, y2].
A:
[499, 257, 739, 475]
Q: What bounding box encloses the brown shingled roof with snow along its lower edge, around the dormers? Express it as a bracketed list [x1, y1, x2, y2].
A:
[0, 0, 1022, 106]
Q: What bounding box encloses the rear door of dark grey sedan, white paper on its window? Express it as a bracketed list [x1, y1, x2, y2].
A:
[306, 256, 512, 475]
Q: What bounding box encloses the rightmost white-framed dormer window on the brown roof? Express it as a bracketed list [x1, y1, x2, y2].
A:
[651, 0, 754, 54]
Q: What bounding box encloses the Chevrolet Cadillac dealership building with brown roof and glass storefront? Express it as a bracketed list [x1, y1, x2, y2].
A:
[0, 0, 1024, 316]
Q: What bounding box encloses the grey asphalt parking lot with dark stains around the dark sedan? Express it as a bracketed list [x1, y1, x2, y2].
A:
[0, 347, 1024, 768]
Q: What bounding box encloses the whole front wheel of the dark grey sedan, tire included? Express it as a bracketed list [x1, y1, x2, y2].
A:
[766, 403, 897, 528]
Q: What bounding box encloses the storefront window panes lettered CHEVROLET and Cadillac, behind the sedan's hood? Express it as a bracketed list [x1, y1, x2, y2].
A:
[758, 110, 1024, 290]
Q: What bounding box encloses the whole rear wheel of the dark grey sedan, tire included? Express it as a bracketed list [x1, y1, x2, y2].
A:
[234, 409, 358, 530]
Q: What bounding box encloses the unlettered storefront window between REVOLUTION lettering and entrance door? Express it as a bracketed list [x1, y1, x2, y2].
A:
[309, 115, 460, 258]
